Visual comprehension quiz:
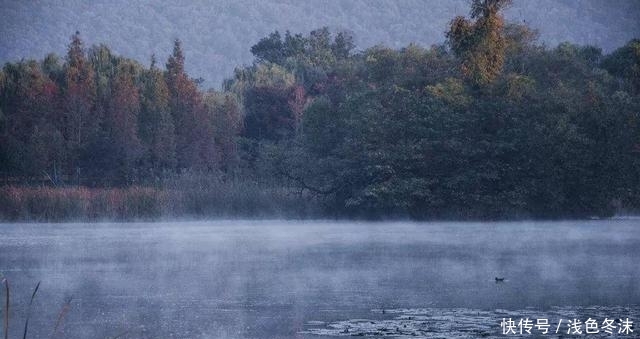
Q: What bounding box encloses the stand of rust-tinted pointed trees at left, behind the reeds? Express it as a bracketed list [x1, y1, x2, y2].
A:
[0, 33, 239, 186]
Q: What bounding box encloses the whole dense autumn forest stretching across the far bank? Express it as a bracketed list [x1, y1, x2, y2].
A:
[0, 0, 640, 219]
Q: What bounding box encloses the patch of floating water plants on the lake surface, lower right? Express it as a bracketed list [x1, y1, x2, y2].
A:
[303, 305, 640, 338]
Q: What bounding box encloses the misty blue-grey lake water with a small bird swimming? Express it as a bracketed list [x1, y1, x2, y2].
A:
[0, 219, 640, 339]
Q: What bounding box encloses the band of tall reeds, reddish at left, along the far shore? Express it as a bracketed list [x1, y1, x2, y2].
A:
[0, 174, 320, 222]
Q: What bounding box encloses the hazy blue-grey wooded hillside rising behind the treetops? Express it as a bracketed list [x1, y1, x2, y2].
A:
[0, 0, 640, 87]
